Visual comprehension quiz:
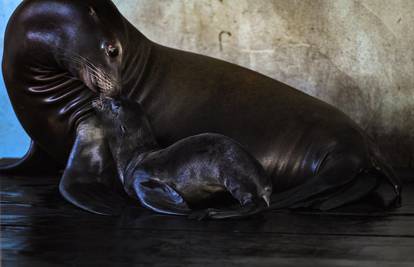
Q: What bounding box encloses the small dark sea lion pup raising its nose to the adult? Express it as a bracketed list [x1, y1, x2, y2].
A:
[93, 98, 272, 219]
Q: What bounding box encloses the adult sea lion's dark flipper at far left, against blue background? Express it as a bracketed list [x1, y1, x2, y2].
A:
[0, 141, 63, 176]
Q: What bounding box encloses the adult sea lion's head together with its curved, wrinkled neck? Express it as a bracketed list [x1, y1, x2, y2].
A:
[3, 0, 126, 163]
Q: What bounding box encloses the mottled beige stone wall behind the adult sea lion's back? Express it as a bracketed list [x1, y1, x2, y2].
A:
[115, 0, 414, 167]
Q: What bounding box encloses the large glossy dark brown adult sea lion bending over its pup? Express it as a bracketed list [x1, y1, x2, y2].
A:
[2, 0, 401, 214]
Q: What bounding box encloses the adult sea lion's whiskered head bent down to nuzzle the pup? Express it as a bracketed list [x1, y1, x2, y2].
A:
[23, 0, 127, 96]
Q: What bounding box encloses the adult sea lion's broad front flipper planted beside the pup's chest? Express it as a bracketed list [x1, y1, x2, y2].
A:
[59, 117, 128, 215]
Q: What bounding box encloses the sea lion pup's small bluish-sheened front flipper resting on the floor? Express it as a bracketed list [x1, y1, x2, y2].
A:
[134, 179, 191, 215]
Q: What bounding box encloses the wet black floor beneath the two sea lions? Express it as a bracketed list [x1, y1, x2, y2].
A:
[0, 173, 414, 266]
